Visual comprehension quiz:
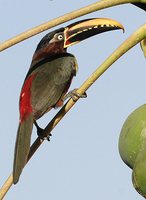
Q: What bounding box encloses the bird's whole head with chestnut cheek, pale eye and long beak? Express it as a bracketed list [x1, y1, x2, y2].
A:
[33, 18, 124, 61]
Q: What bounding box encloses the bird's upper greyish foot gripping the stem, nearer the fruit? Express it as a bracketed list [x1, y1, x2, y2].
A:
[63, 89, 87, 101]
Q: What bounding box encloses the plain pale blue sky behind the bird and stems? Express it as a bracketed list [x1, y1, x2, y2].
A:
[0, 0, 146, 200]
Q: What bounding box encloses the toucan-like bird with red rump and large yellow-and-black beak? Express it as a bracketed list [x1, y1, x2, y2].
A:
[13, 18, 124, 184]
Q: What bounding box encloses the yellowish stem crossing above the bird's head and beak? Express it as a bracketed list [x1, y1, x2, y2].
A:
[0, 0, 146, 52]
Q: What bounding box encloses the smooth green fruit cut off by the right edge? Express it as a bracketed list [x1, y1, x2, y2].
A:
[119, 104, 146, 197]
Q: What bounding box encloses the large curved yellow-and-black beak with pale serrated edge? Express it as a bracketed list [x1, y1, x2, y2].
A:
[64, 18, 124, 48]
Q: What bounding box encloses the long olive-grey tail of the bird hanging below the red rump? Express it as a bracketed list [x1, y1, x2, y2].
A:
[13, 114, 33, 184]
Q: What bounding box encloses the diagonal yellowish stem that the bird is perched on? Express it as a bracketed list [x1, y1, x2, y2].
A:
[0, 24, 146, 200]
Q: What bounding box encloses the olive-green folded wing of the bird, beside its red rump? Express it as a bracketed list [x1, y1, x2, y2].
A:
[31, 56, 77, 119]
